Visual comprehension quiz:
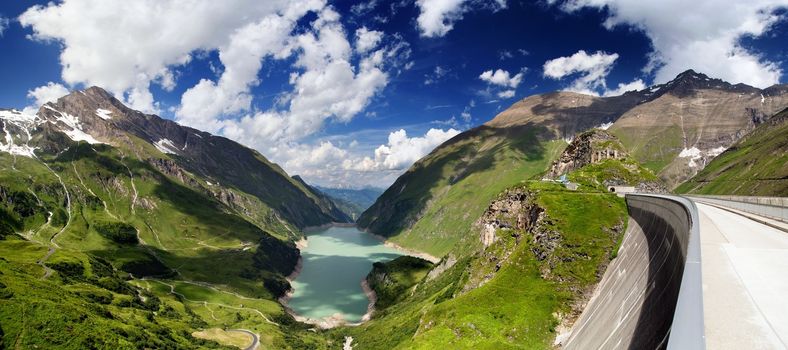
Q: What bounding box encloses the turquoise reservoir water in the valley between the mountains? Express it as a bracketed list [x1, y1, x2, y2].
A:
[287, 226, 403, 323]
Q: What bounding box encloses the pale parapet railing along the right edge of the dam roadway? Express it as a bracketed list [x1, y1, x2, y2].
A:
[685, 195, 788, 223]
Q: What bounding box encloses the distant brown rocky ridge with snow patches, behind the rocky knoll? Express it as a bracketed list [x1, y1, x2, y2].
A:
[485, 70, 788, 187]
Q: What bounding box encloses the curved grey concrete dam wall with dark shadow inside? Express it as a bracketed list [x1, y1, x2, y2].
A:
[563, 195, 705, 350]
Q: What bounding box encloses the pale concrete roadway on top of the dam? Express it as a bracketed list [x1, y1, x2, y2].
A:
[695, 200, 788, 349]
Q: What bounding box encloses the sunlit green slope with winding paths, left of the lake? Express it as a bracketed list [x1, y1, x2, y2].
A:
[0, 133, 324, 349]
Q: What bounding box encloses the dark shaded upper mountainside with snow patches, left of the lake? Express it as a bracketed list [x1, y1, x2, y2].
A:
[41, 87, 347, 228]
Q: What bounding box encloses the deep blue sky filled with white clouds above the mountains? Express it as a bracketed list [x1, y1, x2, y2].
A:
[0, 0, 788, 186]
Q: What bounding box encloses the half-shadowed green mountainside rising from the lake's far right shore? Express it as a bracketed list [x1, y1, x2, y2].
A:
[357, 124, 566, 256]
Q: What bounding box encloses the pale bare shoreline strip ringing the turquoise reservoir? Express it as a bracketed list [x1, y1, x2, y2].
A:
[278, 223, 441, 329]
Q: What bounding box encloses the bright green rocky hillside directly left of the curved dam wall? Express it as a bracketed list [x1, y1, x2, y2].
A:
[342, 128, 660, 349]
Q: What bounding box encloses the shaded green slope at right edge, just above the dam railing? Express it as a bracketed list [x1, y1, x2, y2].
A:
[676, 109, 788, 197]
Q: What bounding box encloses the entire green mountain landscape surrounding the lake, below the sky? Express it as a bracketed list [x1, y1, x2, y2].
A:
[0, 71, 788, 349]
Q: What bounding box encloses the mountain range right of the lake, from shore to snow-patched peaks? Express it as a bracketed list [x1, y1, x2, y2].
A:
[358, 70, 788, 255]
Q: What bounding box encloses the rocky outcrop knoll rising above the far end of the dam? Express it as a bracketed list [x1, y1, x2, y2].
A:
[548, 129, 629, 178]
